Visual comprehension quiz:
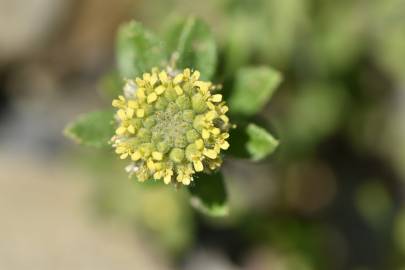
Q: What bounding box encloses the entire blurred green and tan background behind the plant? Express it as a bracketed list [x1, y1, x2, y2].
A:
[0, 0, 405, 270]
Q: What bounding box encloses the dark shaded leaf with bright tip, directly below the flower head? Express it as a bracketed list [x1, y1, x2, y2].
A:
[189, 172, 229, 217]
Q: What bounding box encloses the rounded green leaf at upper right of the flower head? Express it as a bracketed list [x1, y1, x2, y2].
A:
[228, 67, 282, 116]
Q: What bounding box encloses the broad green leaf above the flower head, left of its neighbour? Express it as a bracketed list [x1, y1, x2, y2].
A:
[116, 21, 167, 78]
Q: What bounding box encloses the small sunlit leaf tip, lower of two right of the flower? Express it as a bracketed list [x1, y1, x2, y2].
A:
[246, 123, 279, 161]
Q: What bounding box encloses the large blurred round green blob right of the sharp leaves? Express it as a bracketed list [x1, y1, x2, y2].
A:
[280, 81, 348, 155]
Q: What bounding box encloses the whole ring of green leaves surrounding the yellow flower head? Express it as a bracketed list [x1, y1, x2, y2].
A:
[65, 17, 281, 216]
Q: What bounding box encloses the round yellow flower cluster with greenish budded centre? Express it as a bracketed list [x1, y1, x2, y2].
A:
[111, 68, 230, 185]
